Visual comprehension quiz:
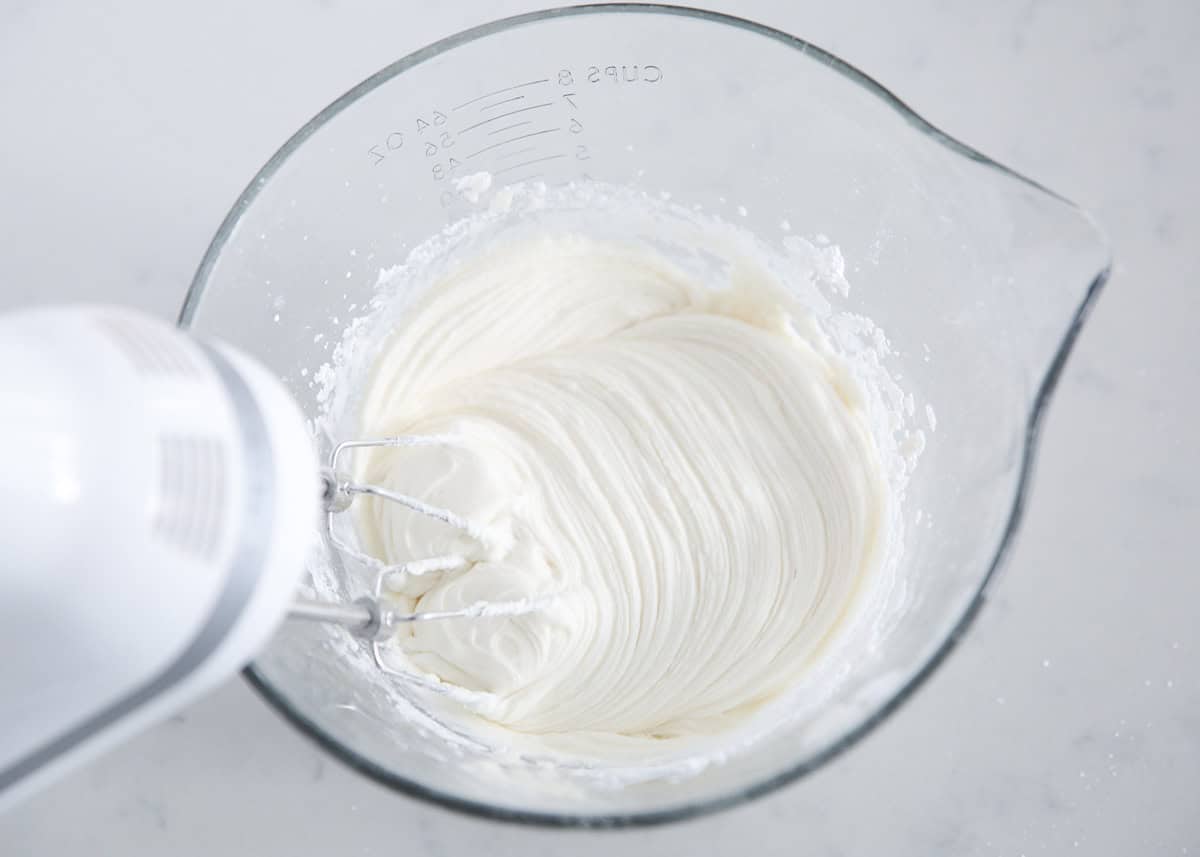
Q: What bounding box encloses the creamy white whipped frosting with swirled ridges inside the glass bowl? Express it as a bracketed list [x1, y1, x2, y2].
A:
[355, 231, 888, 755]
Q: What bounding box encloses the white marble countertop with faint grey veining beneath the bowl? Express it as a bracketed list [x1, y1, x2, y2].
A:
[0, 0, 1200, 857]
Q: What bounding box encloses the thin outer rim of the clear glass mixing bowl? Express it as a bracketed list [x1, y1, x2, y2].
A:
[178, 2, 1111, 828]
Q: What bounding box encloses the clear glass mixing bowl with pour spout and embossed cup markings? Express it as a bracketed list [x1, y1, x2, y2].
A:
[180, 6, 1108, 825]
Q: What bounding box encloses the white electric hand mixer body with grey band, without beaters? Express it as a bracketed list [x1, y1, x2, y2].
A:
[0, 307, 319, 807]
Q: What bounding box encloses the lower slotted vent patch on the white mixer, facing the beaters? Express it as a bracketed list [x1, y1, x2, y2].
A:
[152, 435, 228, 561]
